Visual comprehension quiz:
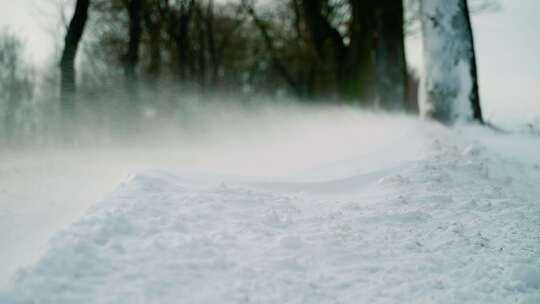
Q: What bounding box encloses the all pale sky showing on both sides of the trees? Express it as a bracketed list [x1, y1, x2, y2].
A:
[0, 0, 540, 124]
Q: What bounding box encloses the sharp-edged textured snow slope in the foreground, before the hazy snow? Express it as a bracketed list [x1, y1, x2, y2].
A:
[0, 113, 540, 304]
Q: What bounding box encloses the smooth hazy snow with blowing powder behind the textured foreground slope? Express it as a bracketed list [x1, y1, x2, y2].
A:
[0, 107, 428, 289]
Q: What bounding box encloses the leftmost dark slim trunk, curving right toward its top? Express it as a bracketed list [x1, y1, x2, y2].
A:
[60, 0, 90, 121]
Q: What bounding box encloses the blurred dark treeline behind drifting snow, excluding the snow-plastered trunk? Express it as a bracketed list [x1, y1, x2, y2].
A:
[0, 0, 428, 146]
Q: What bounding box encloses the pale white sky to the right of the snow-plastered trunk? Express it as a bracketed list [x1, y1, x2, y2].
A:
[473, 0, 540, 126]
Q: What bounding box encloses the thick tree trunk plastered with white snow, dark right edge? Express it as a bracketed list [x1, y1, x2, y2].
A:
[421, 0, 482, 124]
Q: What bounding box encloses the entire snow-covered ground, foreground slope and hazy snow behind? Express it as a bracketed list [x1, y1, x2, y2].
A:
[0, 109, 540, 304]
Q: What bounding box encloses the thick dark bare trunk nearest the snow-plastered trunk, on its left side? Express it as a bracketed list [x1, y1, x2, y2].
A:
[375, 0, 407, 111]
